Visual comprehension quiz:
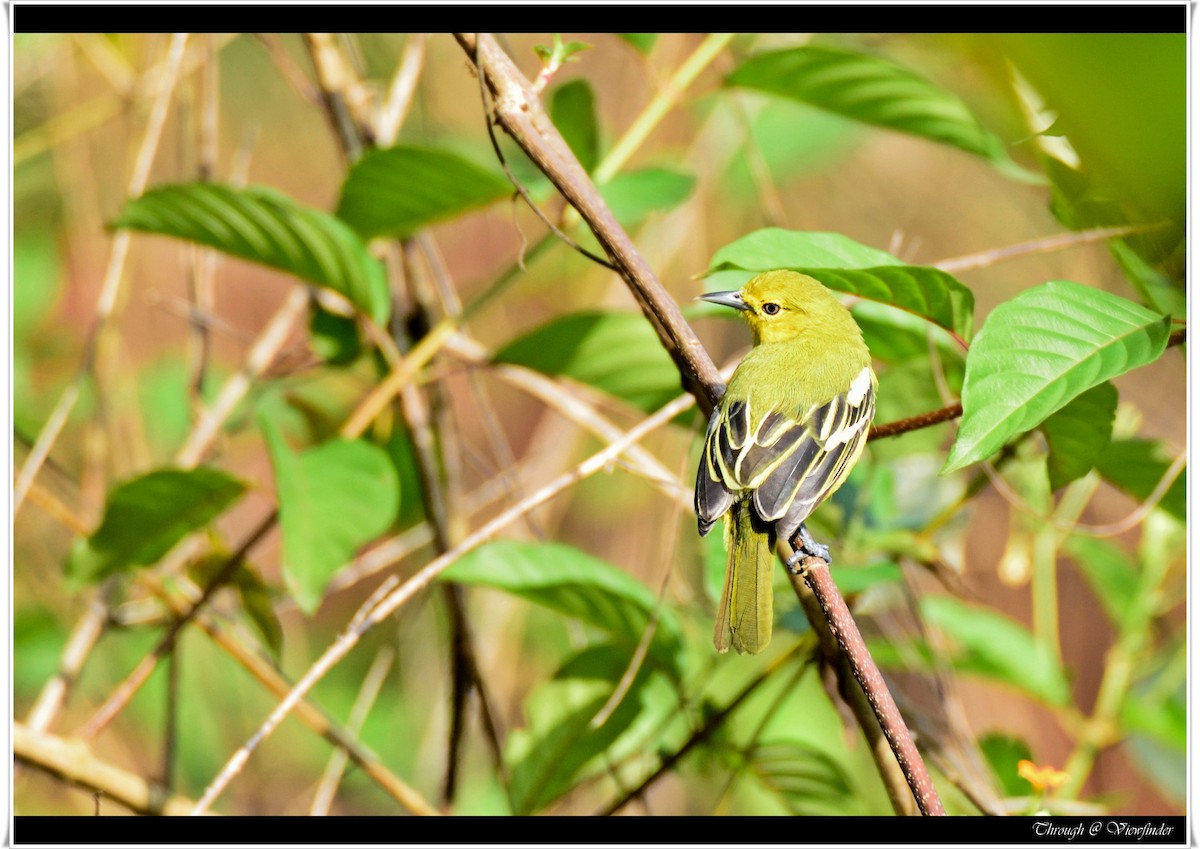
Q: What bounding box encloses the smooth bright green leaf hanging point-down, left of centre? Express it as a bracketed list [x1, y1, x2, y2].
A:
[259, 416, 400, 613]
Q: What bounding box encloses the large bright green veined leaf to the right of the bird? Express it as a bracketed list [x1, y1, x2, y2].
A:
[942, 281, 1170, 472]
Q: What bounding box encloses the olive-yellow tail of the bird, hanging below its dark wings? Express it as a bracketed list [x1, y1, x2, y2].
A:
[713, 499, 775, 655]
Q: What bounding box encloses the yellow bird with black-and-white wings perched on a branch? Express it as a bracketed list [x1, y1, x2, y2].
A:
[696, 271, 878, 654]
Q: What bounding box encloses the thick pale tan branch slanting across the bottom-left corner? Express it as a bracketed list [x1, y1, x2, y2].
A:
[12, 722, 213, 817]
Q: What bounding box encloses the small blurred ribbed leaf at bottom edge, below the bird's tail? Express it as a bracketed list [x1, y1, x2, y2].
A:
[748, 740, 853, 817]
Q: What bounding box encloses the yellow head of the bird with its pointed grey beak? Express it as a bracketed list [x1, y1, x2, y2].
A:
[701, 270, 862, 344]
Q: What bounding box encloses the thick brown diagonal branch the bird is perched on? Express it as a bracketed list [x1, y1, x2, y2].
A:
[455, 32, 940, 813]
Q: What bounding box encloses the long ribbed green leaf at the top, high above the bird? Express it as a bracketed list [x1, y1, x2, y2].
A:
[725, 46, 1034, 180]
